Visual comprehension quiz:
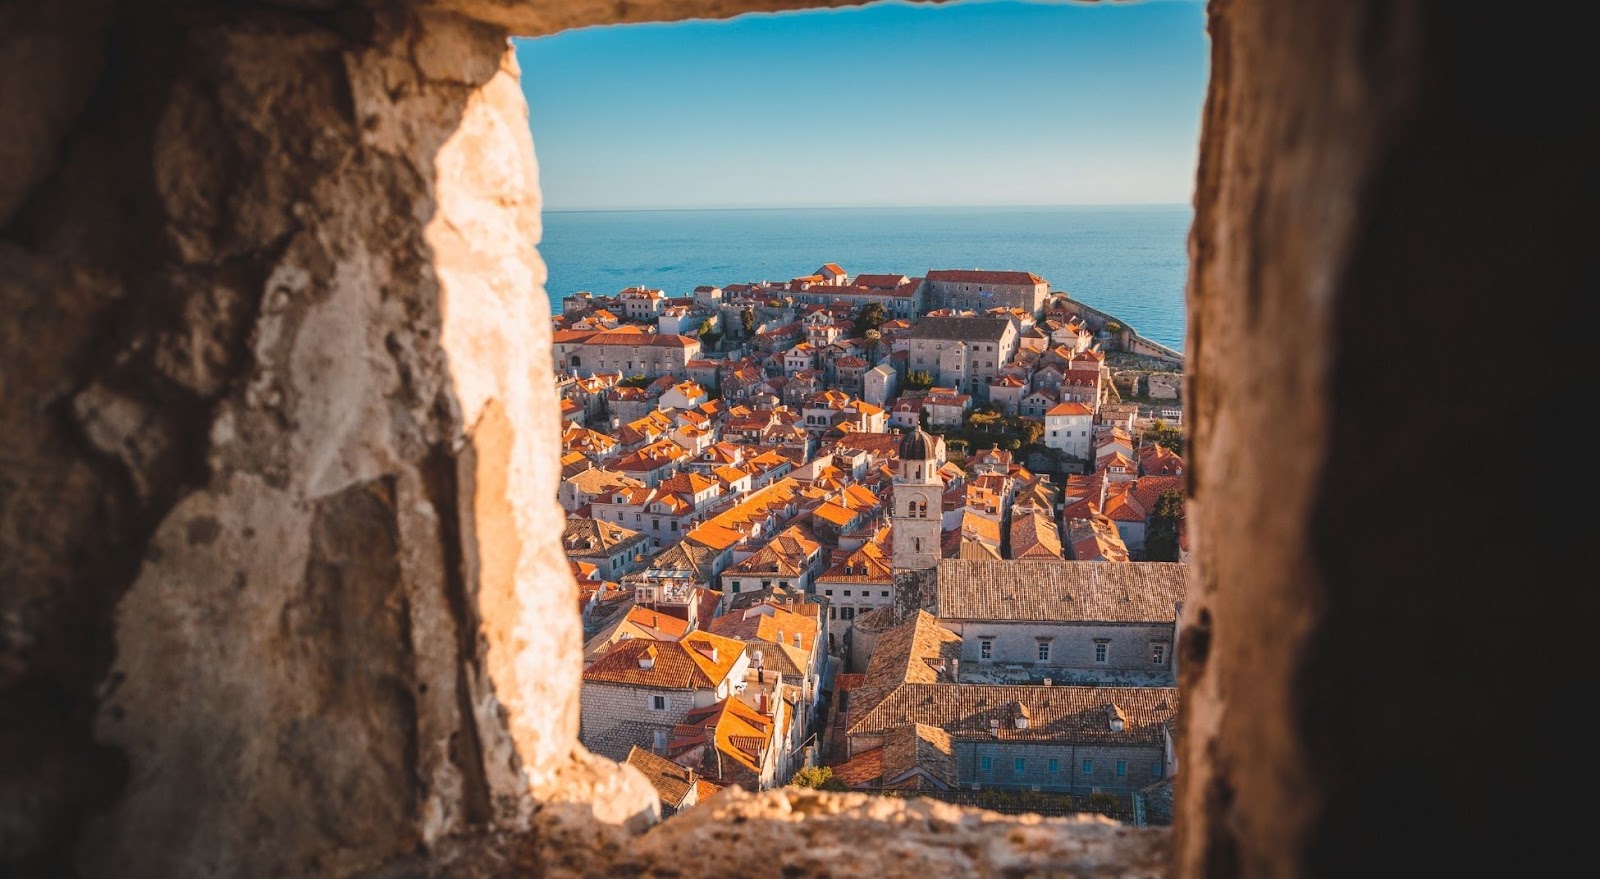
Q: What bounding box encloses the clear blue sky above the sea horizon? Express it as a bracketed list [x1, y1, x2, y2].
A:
[517, 0, 1210, 211]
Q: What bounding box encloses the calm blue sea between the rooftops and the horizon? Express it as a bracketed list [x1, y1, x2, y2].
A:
[539, 205, 1194, 351]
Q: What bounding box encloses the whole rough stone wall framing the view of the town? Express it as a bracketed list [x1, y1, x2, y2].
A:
[0, 0, 1580, 879]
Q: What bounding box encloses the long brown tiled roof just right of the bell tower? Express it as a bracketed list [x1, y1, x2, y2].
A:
[938, 559, 1189, 623]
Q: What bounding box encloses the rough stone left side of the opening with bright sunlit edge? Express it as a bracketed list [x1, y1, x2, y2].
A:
[0, 3, 654, 876]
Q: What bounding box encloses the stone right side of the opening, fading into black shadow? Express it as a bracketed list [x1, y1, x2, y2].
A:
[1173, 0, 1600, 877]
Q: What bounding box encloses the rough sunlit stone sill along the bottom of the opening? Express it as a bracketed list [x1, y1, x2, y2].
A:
[365, 788, 1168, 879]
